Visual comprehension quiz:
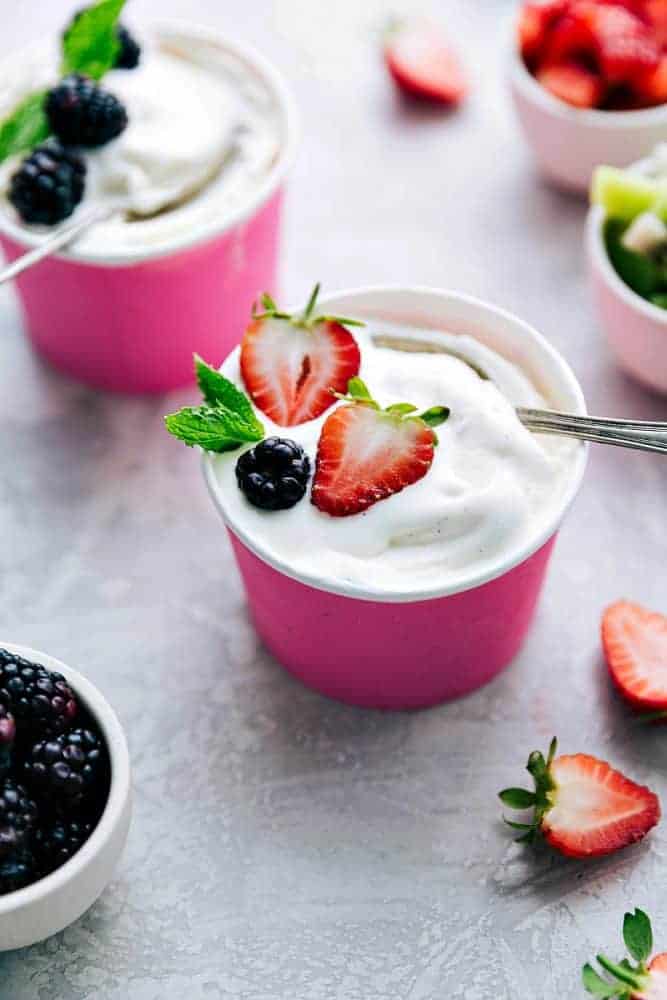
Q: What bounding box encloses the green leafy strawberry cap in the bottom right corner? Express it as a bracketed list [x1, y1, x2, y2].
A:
[581, 908, 653, 1000]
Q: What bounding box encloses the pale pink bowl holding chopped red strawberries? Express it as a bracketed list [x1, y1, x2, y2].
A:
[509, 11, 667, 193]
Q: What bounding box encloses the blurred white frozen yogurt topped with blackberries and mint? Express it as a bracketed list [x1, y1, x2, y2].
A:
[0, 30, 283, 254]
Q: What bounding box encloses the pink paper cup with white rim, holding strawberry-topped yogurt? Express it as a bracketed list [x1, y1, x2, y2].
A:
[204, 288, 587, 709]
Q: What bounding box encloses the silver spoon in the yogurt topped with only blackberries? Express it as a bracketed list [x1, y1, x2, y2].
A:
[0, 146, 239, 285]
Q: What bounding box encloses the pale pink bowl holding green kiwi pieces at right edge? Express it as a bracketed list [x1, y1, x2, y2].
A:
[586, 205, 667, 393]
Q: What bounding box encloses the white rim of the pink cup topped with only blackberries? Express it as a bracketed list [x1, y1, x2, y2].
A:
[0, 18, 300, 267]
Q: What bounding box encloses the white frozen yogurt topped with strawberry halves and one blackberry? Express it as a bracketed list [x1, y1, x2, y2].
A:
[211, 321, 580, 593]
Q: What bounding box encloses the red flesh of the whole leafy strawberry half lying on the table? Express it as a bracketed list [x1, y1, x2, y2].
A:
[542, 754, 660, 858]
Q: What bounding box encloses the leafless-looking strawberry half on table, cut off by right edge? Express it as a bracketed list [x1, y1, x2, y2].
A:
[602, 601, 667, 712]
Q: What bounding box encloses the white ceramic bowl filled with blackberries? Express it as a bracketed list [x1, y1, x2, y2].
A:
[0, 642, 132, 948]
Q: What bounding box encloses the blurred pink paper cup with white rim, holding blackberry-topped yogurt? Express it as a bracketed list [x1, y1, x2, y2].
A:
[0, 22, 296, 393]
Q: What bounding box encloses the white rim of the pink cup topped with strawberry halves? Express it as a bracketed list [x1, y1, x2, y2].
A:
[202, 285, 588, 604]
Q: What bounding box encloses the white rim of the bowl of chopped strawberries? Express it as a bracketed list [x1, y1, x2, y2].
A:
[509, 3, 667, 132]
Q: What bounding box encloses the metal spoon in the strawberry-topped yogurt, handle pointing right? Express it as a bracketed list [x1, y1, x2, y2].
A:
[373, 334, 667, 455]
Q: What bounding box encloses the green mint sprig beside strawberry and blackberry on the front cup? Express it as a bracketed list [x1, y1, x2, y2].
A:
[164, 355, 264, 452]
